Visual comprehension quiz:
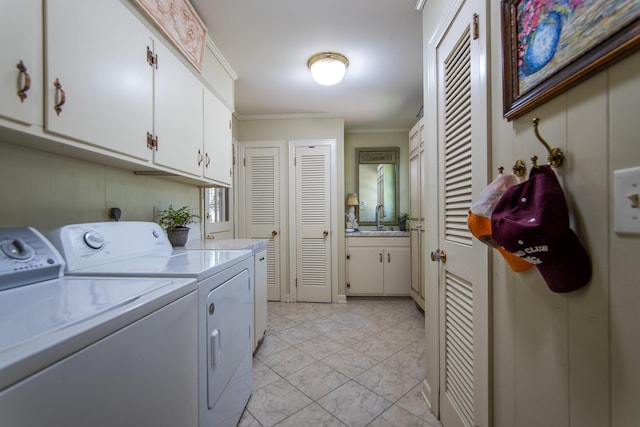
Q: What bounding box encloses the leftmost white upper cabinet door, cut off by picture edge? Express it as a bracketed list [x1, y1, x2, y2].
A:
[0, 0, 43, 126]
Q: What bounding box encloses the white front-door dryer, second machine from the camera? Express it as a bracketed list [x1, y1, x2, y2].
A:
[50, 222, 254, 427]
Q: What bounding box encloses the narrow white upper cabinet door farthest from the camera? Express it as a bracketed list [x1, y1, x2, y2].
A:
[204, 89, 233, 185]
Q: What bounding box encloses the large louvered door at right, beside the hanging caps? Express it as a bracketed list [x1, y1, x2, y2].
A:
[437, 1, 489, 427]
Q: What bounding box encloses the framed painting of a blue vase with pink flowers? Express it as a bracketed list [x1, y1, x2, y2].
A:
[501, 0, 640, 120]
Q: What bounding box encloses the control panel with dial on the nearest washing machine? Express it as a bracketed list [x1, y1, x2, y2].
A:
[0, 227, 64, 290]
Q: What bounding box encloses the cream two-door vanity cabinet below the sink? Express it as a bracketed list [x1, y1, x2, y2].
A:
[346, 236, 411, 296]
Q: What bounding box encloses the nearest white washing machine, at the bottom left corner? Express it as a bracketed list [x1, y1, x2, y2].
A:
[0, 227, 198, 427]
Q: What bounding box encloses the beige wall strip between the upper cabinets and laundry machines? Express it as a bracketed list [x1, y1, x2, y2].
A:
[0, 142, 200, 239]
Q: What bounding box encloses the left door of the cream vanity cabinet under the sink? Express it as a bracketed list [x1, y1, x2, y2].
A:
[347, 247, 384, 295]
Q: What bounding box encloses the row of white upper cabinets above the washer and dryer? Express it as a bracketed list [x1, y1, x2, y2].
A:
[23, 0, 234, 186]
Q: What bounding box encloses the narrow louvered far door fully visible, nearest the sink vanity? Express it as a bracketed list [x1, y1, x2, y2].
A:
[295, 145, 332, 302]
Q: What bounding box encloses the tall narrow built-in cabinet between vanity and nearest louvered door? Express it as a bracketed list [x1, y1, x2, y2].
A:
[409, 120, 425, 310]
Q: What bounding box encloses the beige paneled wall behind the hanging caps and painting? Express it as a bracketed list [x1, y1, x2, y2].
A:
[423, 0, 640, 427]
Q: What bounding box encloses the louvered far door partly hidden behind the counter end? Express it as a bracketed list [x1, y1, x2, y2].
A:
[244, 147, 280, 301]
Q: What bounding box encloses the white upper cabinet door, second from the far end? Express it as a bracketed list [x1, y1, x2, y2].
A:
[153, 41, 203, 177]
